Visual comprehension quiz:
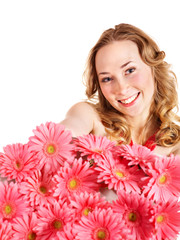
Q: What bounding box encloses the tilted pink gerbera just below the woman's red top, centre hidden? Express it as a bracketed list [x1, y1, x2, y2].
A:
[115, 144, 157, 170]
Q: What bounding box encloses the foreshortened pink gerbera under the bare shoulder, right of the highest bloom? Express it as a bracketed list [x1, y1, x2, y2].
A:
[73, 134, 115, 164]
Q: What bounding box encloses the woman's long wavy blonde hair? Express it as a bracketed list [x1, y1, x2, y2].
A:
[84, 23, 180, 146]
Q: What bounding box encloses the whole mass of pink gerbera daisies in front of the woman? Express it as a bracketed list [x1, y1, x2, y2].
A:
[0, 122, 180, 240]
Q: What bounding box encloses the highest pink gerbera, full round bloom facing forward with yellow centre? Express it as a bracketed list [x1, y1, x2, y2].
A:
[29, 122, 72, 172]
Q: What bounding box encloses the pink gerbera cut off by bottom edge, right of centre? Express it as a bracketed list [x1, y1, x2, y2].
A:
[74, 208, 125, 240]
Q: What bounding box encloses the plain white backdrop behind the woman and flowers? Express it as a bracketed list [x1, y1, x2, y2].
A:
[0, 0, 180, 151]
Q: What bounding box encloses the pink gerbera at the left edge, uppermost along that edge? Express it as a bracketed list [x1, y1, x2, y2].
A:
[0, 143, 39, 182]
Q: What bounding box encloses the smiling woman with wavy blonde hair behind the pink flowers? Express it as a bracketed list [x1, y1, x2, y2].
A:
[61, 24, 180, 158]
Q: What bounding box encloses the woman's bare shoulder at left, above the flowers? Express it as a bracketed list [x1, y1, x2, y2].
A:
[61, 102, 105, 137]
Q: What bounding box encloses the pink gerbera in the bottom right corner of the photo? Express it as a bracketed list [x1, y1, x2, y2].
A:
[154, 200, 180, 240]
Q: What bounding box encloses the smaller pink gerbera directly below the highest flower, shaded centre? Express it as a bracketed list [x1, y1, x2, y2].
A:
[19, 171, 54, 208]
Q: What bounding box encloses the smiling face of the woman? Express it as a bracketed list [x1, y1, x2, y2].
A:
[95, 40, 154, 122]
